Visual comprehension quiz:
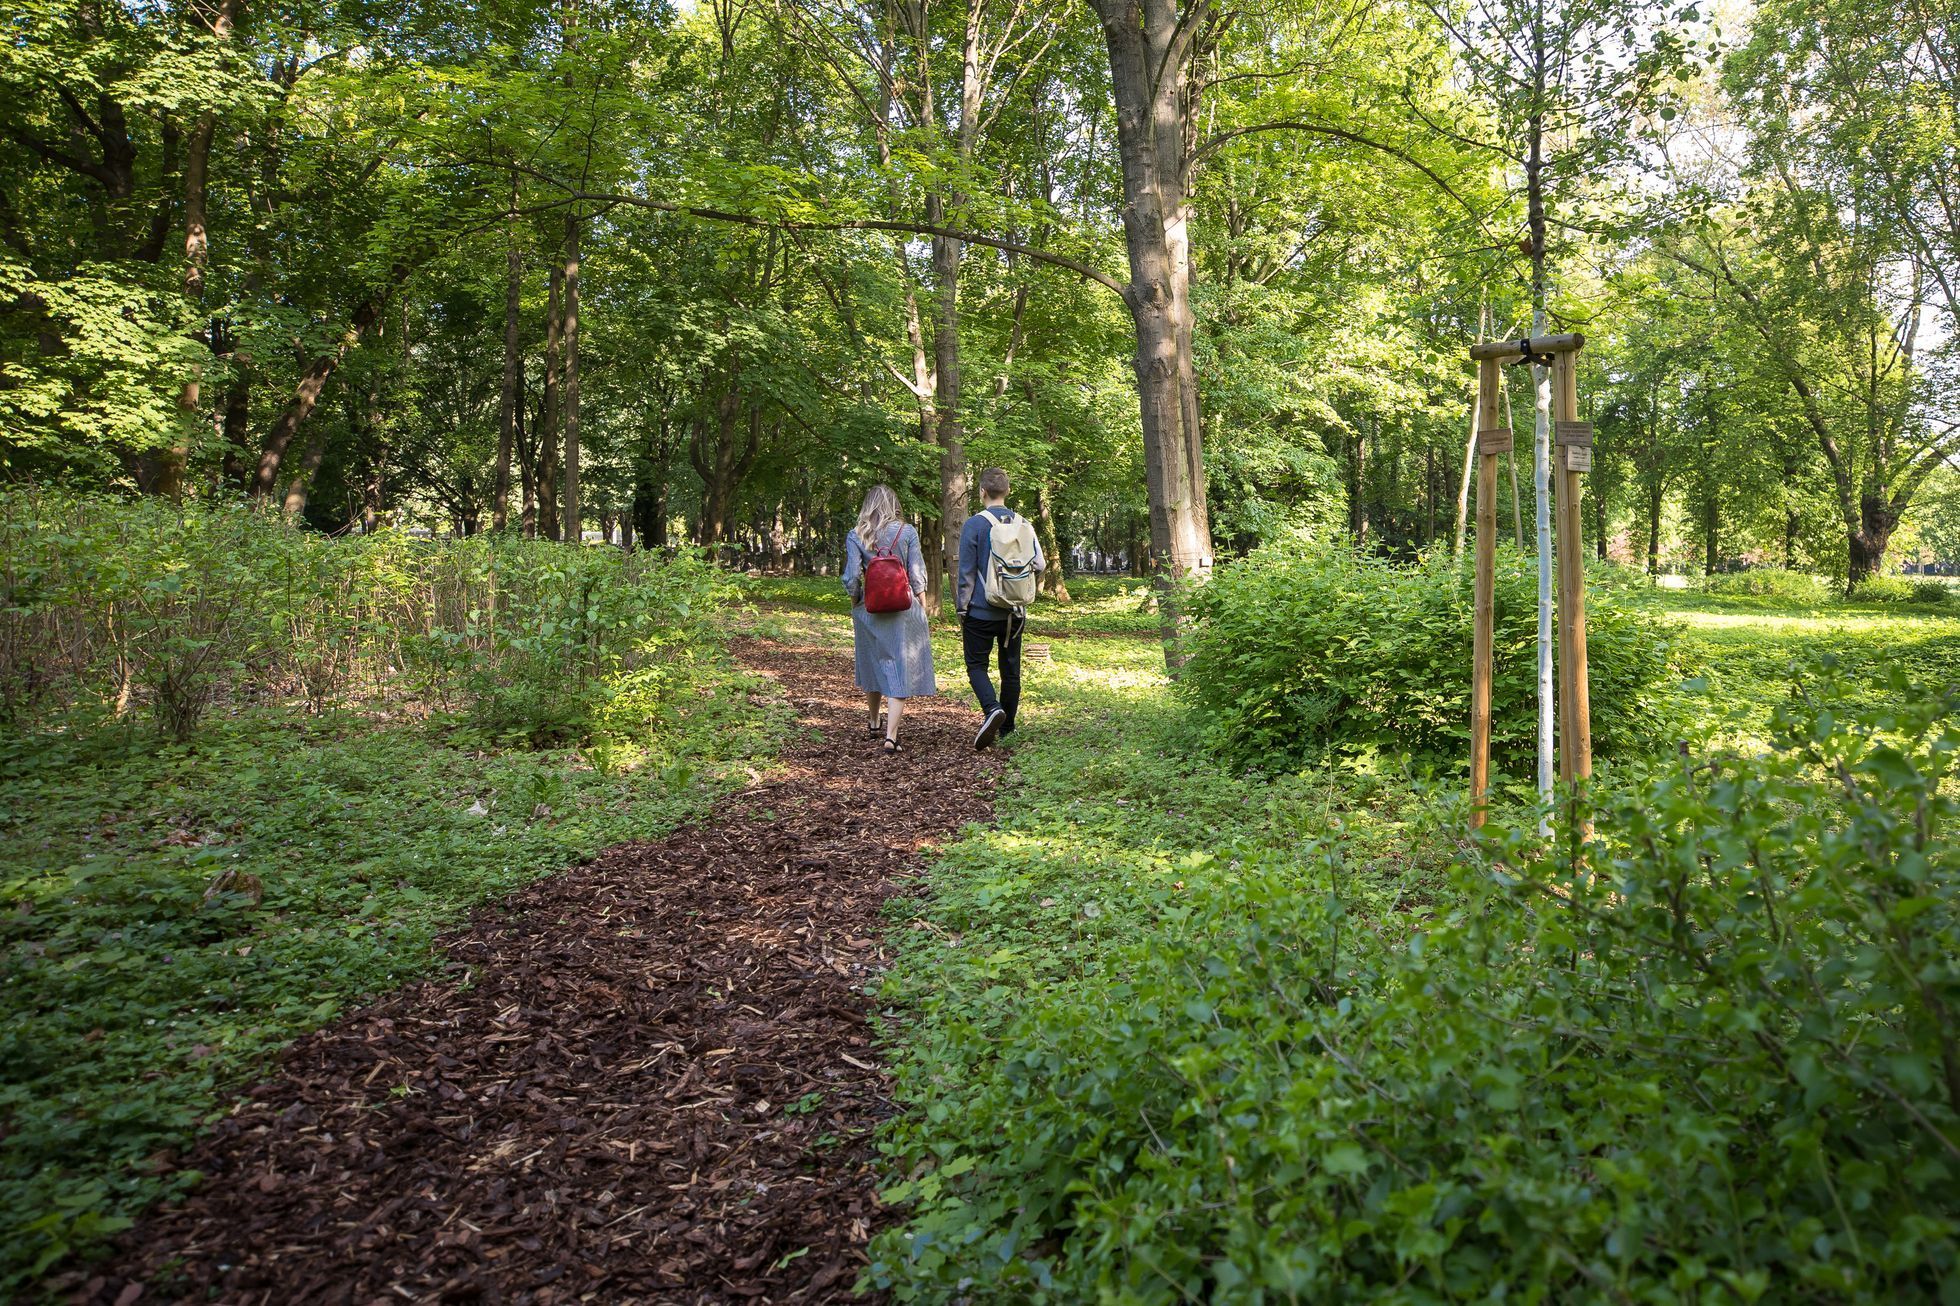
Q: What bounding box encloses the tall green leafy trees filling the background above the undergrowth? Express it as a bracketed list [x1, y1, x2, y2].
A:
[0, 0, 1960, 611]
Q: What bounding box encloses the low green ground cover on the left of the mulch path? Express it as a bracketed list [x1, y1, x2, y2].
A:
[0, 641, 786, 1298]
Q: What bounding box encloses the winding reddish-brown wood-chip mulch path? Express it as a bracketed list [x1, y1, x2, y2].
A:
[74, 641, 1000, 1306]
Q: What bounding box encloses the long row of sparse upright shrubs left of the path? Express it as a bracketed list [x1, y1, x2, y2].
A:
[0, 490, 733, 745]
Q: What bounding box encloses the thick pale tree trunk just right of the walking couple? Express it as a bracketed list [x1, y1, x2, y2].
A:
[1096, 0, 1211, 671]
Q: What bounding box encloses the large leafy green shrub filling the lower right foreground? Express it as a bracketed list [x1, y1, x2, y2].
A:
[866, 666, 1960, 1304]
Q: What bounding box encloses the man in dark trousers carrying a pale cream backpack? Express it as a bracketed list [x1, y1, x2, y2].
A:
[955, 467, 1047, 749]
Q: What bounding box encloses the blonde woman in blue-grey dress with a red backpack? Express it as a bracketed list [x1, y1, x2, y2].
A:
[845, 484, 937, 753]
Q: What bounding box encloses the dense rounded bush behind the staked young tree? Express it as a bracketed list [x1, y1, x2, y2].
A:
[1178, 549, 1678, 773]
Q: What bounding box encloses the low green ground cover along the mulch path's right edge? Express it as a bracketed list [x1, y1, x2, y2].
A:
[868, 639, 1454, 1300]
